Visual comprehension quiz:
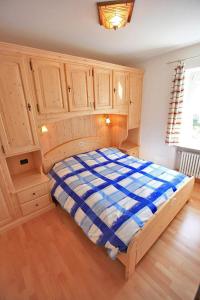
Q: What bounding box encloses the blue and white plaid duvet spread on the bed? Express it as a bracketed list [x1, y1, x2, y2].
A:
[50, 148, 188, 257]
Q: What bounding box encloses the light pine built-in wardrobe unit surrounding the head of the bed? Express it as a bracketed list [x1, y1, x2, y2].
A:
[0, 43, 143, 231]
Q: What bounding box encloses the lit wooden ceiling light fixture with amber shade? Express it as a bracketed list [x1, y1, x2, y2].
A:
[97, 0, 135, 30]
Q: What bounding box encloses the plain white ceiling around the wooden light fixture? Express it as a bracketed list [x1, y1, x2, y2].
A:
[0, 0, 200, 65]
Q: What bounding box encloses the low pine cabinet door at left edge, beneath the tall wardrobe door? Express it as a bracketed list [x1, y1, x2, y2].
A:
[0, 165, 12, 226]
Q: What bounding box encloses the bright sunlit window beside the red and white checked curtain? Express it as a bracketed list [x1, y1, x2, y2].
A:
[180, 68, 200, 150]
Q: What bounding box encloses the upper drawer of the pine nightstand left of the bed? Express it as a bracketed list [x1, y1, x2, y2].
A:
[18, 183, 49, 203]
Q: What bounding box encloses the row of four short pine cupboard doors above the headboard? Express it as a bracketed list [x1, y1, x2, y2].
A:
[31, 58, 138, 119]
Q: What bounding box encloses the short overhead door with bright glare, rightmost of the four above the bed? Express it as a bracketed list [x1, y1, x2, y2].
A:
[113, 71, 129, 108]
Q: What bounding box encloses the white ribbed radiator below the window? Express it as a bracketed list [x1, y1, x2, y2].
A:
[179, 151, 200, 178]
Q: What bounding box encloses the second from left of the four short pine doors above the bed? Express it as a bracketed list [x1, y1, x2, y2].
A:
[65, 63, 94, 111]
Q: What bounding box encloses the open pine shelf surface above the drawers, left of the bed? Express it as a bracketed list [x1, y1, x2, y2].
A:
[12, 170, 49, 192]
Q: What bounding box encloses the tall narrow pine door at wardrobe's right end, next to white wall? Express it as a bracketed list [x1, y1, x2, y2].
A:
[128, 73, 143, 129]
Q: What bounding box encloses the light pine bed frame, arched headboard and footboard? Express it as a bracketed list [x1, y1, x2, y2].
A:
[43, 137, 194, 280]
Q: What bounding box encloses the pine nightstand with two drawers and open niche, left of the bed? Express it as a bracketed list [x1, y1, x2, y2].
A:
[6, 150, 54, 217]
